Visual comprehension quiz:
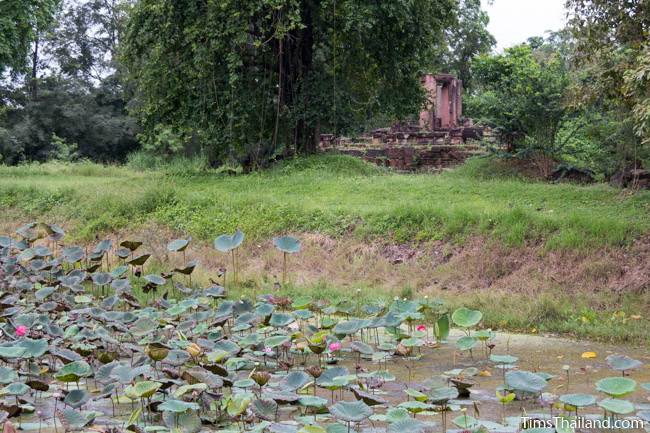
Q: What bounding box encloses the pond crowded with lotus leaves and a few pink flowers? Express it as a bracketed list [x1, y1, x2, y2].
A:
[0, 223, 650, 433]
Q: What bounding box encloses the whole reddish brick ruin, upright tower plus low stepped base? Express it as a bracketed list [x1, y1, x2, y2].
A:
[320, 74, 487, 171]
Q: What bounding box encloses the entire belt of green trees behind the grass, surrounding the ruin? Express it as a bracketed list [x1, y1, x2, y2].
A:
[0, 0, 650, 179]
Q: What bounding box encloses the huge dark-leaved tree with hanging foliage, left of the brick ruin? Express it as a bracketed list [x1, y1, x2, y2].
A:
[124, 0, 455, 166]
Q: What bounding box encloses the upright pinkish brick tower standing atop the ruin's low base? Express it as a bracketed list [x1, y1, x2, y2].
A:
[420, 74, 463, 131]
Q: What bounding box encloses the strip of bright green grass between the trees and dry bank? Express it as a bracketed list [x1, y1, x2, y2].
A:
[0, 155, 650, 249]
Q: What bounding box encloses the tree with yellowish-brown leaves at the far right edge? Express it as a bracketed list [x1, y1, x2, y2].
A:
[566, 0, 650, 165]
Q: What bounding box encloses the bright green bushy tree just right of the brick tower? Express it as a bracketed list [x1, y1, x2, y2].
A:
[466, 44, 569, 176]
